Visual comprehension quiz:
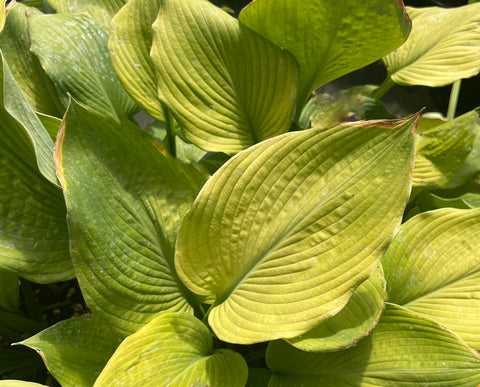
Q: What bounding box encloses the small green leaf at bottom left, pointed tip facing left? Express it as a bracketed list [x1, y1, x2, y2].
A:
[18, 315, 124, 387]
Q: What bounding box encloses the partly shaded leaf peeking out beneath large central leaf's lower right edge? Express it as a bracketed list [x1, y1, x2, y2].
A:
[288, 266, 386, 352]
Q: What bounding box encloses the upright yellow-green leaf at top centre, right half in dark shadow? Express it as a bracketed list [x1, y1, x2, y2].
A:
[151, 0, 298, 153]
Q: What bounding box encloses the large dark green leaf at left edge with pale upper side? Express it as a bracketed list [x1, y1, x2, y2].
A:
[0, 55, 74, 283]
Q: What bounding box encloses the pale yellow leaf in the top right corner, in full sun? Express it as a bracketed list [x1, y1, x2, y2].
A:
[383, 3, 480, 87]
